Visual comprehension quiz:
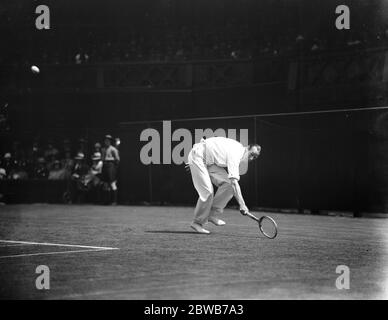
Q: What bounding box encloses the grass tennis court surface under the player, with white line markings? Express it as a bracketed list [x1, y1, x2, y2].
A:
[0, 204, 388, 299]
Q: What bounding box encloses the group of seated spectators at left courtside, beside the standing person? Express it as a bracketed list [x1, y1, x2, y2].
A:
[0, 138, 119, 202]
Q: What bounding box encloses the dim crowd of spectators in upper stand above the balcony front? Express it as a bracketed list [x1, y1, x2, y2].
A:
[3, 23, 388, 64]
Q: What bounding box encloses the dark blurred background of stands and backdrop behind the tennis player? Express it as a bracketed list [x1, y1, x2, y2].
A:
[0, 0, 388, 215]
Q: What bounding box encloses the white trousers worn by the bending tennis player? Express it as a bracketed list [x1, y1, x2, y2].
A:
[188, 142, 233, 225]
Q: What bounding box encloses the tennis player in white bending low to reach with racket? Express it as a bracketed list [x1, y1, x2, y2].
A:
[188, 137, 261, 234]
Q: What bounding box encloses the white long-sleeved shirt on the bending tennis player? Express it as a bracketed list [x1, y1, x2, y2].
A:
[205, 137, 245, 180]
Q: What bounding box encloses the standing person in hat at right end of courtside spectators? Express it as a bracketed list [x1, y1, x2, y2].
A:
[102, 134, 120, 205]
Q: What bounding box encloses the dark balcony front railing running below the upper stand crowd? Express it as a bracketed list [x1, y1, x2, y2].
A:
[1, 48, 388, 92]
